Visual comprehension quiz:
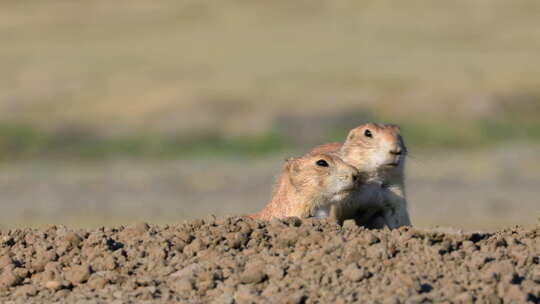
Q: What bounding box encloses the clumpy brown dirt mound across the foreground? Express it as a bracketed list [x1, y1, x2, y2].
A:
[0, 217, 540, 303]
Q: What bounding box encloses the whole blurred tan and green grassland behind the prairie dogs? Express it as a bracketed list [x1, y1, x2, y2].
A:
[0, 0, 540, 229]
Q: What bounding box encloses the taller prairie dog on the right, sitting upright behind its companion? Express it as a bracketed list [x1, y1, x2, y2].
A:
[310, 123, 411, 229]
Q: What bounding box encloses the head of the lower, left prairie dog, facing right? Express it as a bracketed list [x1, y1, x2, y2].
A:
[286, 153, 361, 210]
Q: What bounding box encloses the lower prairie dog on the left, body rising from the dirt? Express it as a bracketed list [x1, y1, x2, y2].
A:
[251, 153, 360, 220]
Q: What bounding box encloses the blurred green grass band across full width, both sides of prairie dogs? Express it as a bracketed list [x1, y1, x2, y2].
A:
[0, 120, 540, 161]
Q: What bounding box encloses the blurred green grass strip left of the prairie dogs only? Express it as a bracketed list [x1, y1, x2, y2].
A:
[0, 125, 290, 161]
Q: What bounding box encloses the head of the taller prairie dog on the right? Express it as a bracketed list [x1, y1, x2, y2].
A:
[341, 123, 407, 172]
